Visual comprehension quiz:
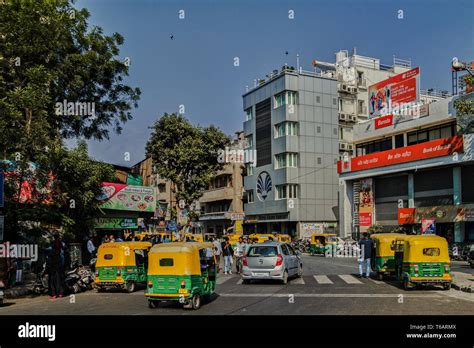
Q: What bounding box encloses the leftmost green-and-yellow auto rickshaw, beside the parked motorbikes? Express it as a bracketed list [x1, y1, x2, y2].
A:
[95, 242, 151, 292]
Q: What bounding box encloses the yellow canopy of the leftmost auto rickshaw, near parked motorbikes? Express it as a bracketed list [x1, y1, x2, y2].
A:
[96, 242, 152, 267]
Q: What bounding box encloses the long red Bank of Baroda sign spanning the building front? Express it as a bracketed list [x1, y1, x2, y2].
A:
[343, 136, 463, 172]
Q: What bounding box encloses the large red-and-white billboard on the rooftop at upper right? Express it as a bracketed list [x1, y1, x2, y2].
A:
[368, 67, 420, 118]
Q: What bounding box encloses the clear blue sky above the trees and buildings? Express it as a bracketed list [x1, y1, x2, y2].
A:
[76, 0, 474, 166]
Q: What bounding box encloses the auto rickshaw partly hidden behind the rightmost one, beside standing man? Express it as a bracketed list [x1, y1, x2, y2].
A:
[370, 233, 405, 280]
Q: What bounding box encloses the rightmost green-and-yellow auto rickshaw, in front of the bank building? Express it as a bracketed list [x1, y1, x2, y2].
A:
[394, 235, 452, 290]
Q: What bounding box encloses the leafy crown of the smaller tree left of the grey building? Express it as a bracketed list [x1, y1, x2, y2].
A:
[146, 113, 230, 205]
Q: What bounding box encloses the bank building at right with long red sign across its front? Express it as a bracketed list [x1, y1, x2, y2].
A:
[338, 96, 474, 243]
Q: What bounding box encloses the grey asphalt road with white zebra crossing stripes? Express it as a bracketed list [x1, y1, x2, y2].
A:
[0, 256, 474, 315]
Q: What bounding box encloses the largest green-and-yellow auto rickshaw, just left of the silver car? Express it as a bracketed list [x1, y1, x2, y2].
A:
[145, 242, 217, 309]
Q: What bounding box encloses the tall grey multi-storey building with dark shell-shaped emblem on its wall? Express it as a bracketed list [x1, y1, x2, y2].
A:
[243, 67, 339, 237]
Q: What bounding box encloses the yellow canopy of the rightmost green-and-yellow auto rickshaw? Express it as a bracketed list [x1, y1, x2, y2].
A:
[395, 235, 450, 262]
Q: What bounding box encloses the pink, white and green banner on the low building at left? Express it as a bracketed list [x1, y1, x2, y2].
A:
[96, 182, 156, 213]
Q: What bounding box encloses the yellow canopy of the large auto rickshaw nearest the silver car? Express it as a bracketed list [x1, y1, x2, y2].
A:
[148, 242, 214, 275]
